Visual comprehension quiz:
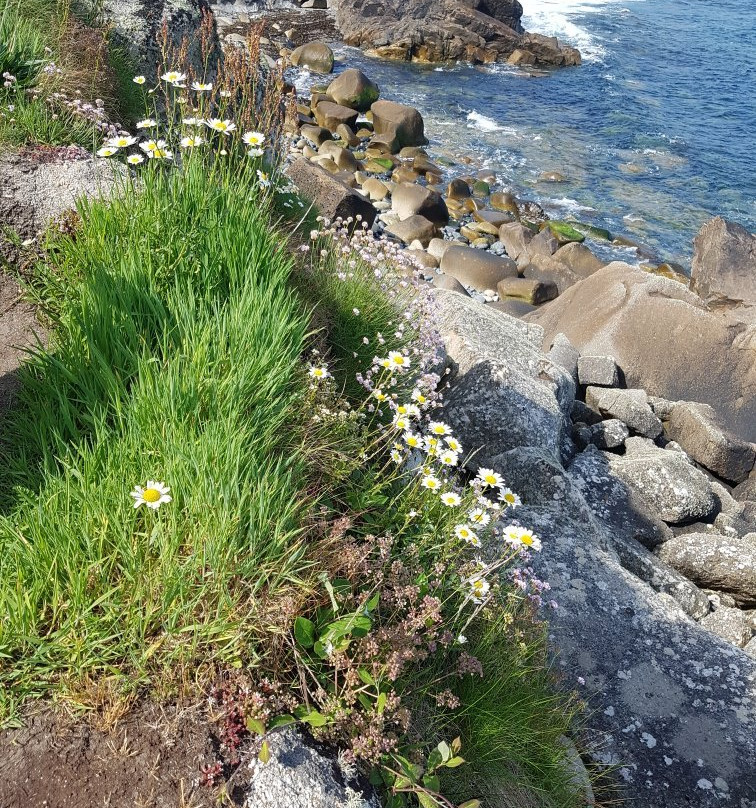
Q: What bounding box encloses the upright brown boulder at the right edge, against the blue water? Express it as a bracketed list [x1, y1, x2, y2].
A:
[691, 216, 756, 303]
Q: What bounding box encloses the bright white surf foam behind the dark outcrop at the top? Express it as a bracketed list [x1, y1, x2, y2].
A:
[522, 0, 636, 62]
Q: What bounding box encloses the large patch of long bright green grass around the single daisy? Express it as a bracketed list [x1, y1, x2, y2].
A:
[0, 164, 316, 717]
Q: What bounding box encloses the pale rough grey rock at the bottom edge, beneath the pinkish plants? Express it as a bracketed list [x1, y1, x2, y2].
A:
[241, 727, 380, 808]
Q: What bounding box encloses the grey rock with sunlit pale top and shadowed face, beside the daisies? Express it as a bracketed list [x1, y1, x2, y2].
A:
[436, 291, 575, 465]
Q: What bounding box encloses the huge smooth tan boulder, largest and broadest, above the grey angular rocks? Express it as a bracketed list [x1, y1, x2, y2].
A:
[527, 263, 756, 441]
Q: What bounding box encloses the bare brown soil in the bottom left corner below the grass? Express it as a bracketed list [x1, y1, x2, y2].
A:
[0, 704, 218, 808]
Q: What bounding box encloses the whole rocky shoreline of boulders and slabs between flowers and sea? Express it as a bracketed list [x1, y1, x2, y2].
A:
[213, 12, 756, 808]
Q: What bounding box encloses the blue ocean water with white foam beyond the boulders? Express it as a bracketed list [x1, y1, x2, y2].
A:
[302, 0, 756, 265]
